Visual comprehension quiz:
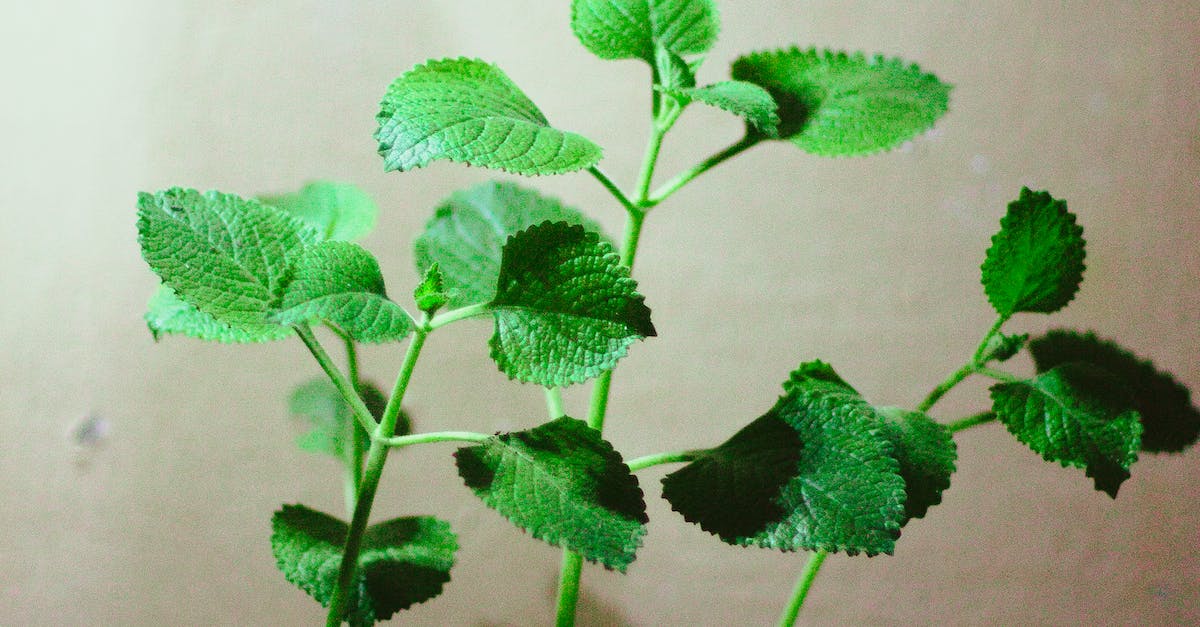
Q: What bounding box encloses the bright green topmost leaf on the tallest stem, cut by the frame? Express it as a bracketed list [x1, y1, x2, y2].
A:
[571, 0, 721, 65]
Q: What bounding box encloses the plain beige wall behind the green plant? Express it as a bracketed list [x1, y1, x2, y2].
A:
[0, 0, 1200, 626]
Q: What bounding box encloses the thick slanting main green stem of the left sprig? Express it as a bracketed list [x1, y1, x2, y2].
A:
[325, 324, 428, 627]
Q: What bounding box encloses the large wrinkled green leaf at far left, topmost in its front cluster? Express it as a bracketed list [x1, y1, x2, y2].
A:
[138, 187, 319, 329]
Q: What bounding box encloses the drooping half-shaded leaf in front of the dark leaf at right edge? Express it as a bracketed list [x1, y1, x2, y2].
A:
[991, 362, 1141, 498]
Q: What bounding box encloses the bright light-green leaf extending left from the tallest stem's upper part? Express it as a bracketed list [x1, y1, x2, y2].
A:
[376, 59, 601, 175]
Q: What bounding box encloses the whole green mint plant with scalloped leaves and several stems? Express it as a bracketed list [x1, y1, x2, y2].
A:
[138, 0, 1200, 625]
